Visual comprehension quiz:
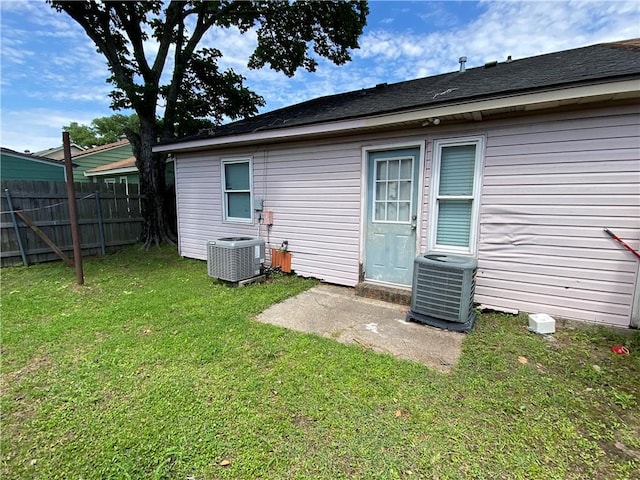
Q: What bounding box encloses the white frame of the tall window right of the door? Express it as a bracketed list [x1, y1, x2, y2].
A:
[428, 136, 485, 256]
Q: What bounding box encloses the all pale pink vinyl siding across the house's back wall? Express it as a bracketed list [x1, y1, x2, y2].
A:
[176, 106, 640, 326]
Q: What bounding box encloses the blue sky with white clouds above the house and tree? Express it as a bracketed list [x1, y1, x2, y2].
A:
[0, 0, 640, 152]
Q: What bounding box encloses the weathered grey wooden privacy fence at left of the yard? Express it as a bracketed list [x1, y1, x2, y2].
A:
[0, 180, 142, 267]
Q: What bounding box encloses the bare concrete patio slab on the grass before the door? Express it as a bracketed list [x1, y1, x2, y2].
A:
[256, 285, 465, 373]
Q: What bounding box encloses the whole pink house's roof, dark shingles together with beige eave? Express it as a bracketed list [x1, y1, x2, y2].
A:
[154, 39, 640, 151]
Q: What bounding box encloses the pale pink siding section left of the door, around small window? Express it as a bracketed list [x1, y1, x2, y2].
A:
[176, 143, 361, 286]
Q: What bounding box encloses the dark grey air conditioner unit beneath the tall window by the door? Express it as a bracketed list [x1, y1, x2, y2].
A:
[407, 254, 478, 332]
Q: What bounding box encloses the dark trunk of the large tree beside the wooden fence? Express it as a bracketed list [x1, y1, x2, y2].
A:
[127, 117, 176, 250]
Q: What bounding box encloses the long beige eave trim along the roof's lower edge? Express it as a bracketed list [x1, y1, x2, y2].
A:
[153, 78, 640, 153]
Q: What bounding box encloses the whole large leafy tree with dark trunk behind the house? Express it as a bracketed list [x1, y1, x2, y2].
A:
[48, 0, 368, 247]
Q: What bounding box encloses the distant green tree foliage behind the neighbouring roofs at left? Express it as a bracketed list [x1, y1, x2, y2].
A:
[62, 113, 140, 148]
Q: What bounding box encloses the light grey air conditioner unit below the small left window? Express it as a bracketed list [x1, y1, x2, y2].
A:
[207, 237, 264, 282]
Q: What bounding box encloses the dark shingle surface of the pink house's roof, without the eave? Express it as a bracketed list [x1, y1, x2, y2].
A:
[163, 39, 640, 143]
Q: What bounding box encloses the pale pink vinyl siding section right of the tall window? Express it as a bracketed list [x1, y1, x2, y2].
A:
[475, 107, 640, 326]
